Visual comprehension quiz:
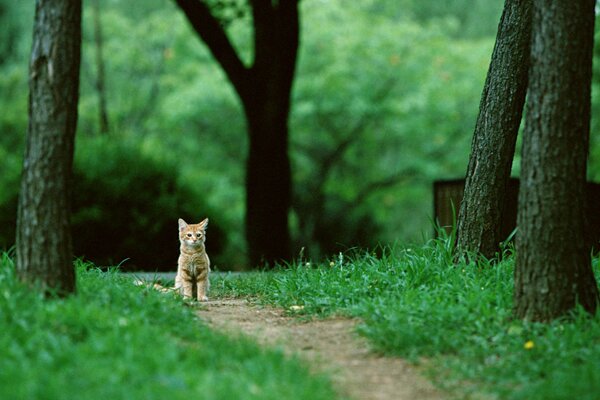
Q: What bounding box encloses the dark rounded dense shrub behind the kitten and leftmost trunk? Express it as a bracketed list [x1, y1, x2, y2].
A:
[0, 139, 225, 270]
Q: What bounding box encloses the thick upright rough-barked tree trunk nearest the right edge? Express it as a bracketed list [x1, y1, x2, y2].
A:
[514, 0, 599, 321]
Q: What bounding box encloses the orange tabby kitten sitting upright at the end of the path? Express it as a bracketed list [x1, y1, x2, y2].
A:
[175, 218, 210, 301]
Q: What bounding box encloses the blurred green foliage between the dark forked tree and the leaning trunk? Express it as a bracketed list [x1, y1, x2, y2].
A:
[291, 1, 493, 258]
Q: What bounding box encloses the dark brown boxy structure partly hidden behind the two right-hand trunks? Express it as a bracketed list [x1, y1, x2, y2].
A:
[433, 178, 600, 253]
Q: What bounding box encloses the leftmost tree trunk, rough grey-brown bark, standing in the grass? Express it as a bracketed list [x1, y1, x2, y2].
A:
[16, 0, 81, 295]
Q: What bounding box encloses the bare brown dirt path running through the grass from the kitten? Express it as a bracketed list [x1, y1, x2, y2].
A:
[198, 299, 443, 400]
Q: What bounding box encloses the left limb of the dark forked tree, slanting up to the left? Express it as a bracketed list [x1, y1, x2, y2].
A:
[174, 0, 249, 96]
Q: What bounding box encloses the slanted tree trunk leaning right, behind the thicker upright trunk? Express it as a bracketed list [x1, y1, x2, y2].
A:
[457, 0, 532, 258]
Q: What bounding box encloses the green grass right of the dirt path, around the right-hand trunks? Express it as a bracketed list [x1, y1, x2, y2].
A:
[213, 241, 600, 400]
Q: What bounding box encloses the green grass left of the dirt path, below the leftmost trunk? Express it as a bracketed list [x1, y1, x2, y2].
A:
[0, 254, 336, 400]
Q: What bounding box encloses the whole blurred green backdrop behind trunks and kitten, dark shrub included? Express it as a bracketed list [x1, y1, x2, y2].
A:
[0, 0, 600, 270]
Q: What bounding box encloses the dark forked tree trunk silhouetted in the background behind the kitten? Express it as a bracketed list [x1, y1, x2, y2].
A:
[175, 0, 299, 265]
